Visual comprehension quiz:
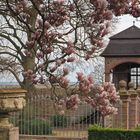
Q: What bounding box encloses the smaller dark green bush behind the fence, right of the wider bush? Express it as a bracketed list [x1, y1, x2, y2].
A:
[50, 115, 68, 127]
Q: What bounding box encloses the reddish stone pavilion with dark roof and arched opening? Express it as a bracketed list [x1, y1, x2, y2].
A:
[101, 25, 140, 89]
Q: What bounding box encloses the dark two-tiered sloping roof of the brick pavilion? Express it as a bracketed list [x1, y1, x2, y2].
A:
[100, 25, 140, 57]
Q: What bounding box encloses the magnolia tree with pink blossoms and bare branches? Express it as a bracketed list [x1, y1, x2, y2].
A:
[0, 0, 140, 114]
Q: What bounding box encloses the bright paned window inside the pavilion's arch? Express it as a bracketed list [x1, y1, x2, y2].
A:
[130, 67, 140, 88]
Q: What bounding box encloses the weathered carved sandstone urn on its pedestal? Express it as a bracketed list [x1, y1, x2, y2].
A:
[0, 89, 27, 140]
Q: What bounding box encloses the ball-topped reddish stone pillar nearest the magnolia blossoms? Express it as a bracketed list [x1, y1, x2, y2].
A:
[119, 80, 130, 129]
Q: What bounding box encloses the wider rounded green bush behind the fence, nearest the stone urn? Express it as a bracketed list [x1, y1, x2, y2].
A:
[19, 119, 52, 135]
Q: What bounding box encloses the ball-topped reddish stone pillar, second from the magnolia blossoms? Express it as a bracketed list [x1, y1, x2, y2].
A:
[128, 82, 138, 128]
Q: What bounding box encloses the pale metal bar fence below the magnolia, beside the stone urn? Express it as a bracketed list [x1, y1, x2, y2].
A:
[10, 93, 103, 137]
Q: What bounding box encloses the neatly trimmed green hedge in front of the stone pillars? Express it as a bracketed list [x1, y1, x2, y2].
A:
[88, 126, 140, 140]
